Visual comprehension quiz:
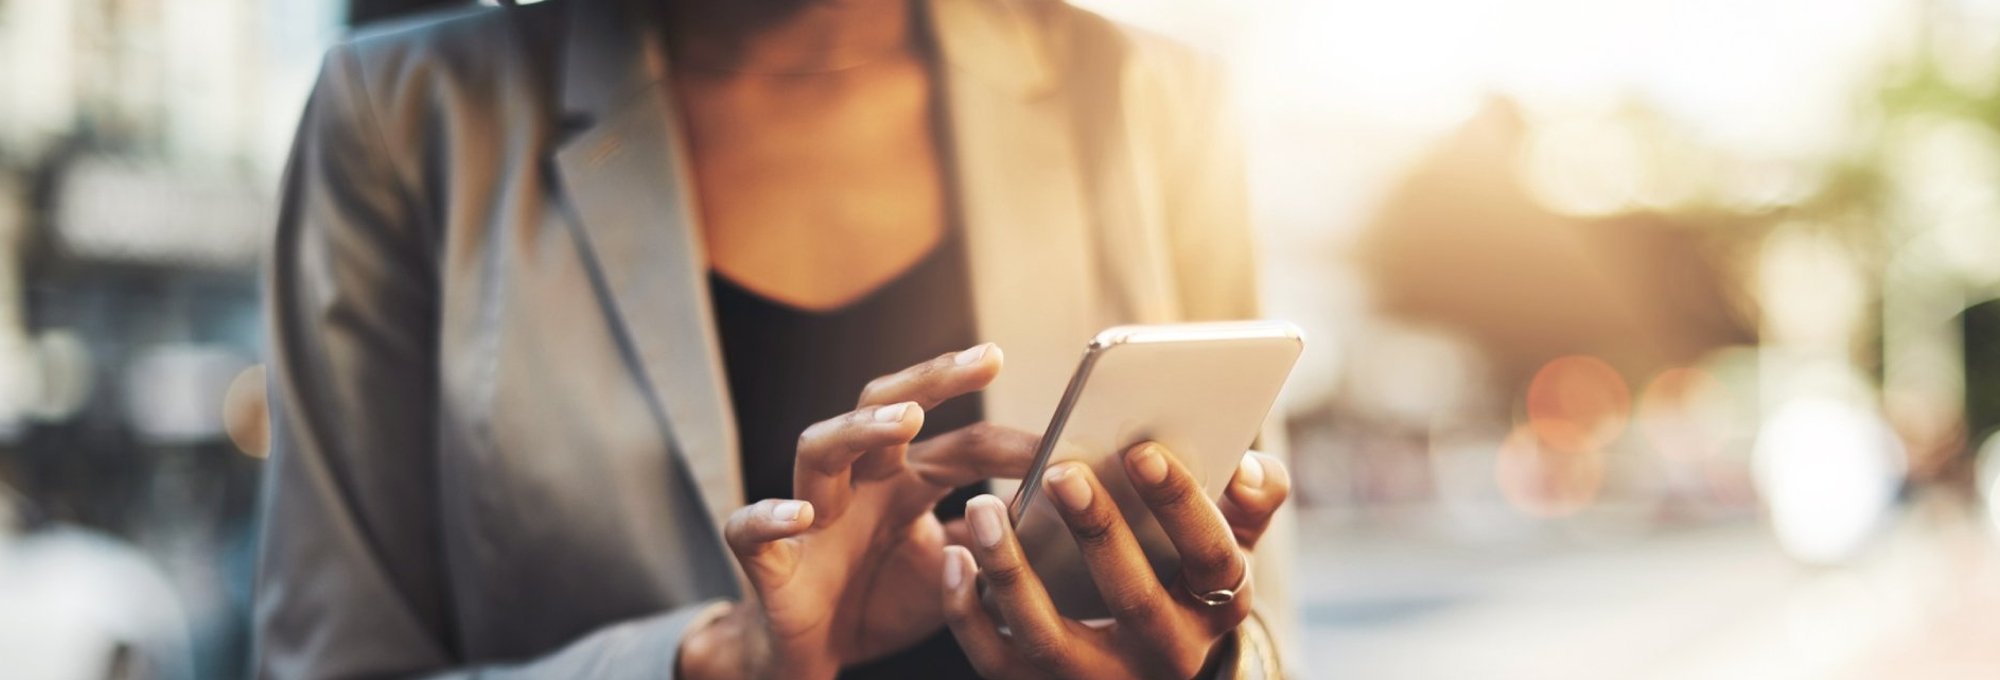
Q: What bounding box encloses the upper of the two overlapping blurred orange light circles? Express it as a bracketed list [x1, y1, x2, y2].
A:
[1528, 356, 1632, 454]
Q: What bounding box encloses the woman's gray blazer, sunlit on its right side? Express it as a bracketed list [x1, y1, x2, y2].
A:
[256, 0, 1286, 678]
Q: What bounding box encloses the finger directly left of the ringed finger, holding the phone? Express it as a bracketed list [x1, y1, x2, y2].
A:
[1042, 462, 1178, 642]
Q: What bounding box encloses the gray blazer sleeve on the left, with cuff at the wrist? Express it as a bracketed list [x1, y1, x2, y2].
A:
[254, 46, 720, 678]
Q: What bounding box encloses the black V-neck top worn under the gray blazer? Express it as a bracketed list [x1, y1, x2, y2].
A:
[708, 228, 982, 678]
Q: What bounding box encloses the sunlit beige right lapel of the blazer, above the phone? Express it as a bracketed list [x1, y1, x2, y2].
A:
[928, 0, 1106, 432]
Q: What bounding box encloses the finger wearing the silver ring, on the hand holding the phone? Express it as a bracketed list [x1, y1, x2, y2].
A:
[1124, 442, 1248, 614]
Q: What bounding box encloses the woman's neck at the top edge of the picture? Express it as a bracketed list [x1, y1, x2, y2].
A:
[664, 0, 912, 74]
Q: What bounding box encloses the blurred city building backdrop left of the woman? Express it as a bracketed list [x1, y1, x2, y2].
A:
[0, 0, 346, 678]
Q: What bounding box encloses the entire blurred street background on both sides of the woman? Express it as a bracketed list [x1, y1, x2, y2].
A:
[0, 0, 2000, 678]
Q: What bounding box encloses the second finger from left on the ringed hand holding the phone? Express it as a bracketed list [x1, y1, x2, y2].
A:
[966, 494, 1080, 676]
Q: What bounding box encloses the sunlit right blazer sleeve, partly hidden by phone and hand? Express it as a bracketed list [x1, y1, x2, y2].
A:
[1156, 50, 1298, 678]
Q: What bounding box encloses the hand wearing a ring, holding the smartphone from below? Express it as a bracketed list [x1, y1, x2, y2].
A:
[944, 444, 1292, 680]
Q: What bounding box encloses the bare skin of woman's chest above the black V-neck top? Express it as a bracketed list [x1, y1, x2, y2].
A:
[676, 62, 948, 308]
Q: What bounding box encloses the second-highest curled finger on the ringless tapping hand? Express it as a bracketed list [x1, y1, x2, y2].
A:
[792, 402, 924, 524]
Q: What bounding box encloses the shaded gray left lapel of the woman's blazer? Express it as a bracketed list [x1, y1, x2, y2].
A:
[556, 2, 742, 530]
